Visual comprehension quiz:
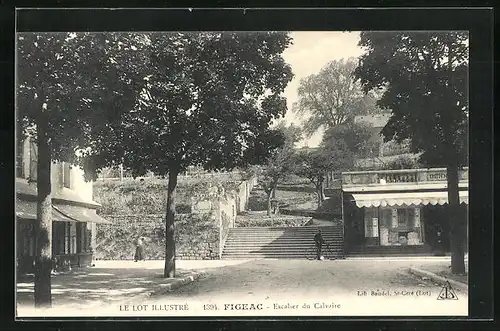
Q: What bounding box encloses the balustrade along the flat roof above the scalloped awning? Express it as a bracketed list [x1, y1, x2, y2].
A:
[342, 167, 469, 185]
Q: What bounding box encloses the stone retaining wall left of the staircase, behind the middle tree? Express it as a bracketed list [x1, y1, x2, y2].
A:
[96, 179, 255, 260]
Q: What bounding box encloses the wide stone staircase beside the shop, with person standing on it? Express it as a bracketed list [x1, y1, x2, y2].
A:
[222, 225, 344, 259]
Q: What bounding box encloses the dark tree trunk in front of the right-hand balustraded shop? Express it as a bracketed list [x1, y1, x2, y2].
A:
[446, 165, 465, 274]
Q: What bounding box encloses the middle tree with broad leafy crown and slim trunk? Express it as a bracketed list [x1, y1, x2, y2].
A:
[77, 32, 292, 277]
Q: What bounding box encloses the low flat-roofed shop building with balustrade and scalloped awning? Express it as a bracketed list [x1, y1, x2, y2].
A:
[342, 168, 468, 254]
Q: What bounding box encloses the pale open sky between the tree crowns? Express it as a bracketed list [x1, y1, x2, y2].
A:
[283, 31, 362, 147]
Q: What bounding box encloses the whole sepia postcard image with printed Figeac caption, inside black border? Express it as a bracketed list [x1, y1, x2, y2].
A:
[15, 26, 469, 319]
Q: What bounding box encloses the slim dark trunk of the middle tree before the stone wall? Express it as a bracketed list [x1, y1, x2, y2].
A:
[163, 171, 179, 278]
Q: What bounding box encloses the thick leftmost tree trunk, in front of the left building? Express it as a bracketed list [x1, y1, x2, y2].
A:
[34, 114, 52, 308]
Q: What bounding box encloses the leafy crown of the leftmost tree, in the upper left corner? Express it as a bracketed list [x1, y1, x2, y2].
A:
[16, 33, 149, 162]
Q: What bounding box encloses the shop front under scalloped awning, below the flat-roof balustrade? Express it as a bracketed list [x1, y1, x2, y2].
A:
[343, 190, 468, 253]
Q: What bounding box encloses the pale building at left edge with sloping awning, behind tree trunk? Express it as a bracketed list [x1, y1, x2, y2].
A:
[15, 138, 109, 273]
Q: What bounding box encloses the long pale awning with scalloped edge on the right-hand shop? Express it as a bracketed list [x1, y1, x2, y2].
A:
[352, 191, 469, 208]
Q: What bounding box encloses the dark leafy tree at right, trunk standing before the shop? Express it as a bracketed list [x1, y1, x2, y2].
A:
[356, 31, 469, 273]
